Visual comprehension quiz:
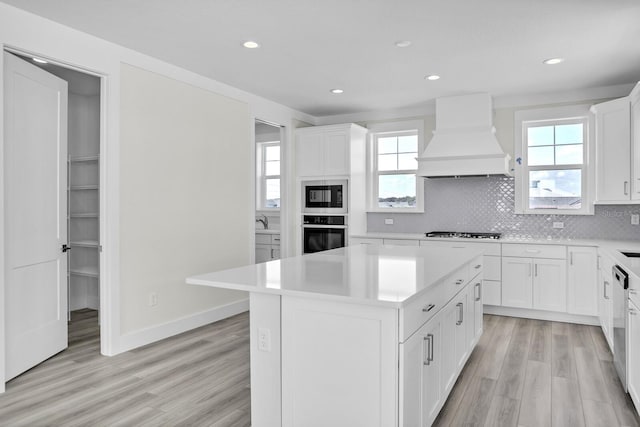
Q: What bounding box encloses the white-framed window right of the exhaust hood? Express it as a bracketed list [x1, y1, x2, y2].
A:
[516, 107, 593, 215]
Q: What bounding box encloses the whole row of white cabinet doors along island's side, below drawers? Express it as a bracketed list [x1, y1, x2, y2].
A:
[400, 275, 482, 427]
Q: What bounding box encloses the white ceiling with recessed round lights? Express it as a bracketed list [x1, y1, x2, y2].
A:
[2, 0, 640, 117]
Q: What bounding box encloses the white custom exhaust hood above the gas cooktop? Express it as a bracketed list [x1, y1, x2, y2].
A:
[417, 93, 511, 178]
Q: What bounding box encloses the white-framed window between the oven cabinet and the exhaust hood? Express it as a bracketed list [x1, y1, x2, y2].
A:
[369, 121, 424, 212]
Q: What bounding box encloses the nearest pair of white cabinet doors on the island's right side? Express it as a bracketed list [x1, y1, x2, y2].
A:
[400, 317, 443, 427]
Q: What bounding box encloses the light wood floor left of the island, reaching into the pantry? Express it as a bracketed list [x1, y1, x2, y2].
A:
[0, 310, 250, 427]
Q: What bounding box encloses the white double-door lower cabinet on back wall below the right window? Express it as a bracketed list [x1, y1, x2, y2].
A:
[502, 257, 567, 312]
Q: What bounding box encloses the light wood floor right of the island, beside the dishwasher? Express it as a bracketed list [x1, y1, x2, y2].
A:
[434, 315, 640, 427]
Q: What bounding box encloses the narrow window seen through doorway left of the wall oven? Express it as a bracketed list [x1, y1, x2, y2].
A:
[258, 141, 280, 209]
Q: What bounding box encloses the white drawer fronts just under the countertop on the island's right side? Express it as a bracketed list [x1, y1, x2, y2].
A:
[400, 263, 468, 342]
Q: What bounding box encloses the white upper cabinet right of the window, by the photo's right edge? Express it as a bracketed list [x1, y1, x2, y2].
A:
[591, 87, 640, 204]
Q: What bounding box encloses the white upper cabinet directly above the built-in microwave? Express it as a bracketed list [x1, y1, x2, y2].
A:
[296, 123, 367, 178]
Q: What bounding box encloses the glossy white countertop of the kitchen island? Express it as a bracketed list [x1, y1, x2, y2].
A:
[186, 245, 482, 308]
